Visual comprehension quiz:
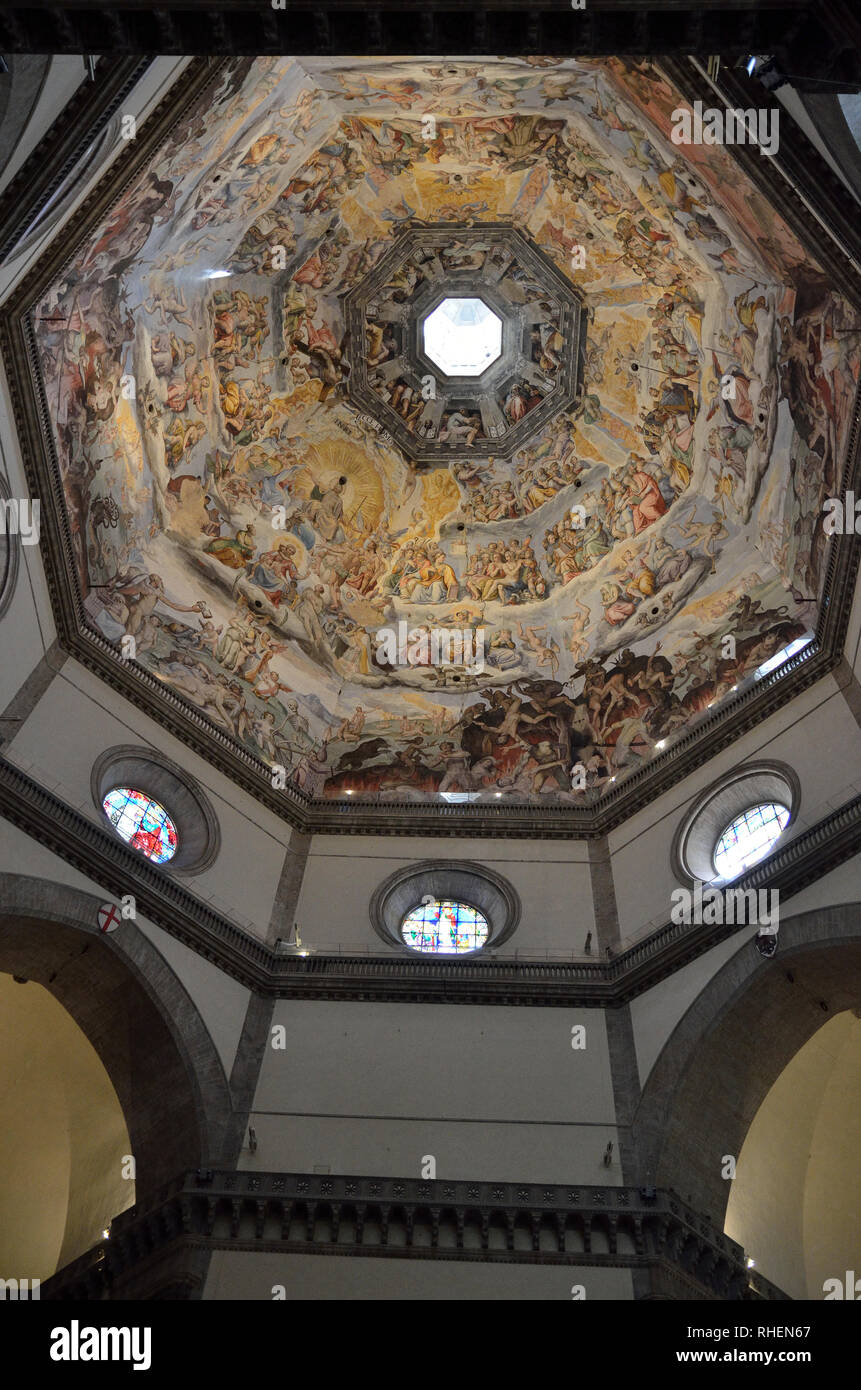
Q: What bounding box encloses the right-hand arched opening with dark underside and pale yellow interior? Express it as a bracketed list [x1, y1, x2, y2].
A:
[636, 904, 861, 1298]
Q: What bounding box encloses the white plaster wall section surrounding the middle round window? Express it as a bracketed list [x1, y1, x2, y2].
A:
[296, 835, 595, 958]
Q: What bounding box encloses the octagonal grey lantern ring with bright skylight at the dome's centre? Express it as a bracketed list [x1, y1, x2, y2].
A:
[346, 222, 587, 464]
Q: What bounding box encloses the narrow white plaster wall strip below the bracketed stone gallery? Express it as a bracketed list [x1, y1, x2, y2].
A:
[203, 1250, 634, 1301]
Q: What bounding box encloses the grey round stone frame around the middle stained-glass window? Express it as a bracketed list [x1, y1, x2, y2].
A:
[369, 859, 520, 962]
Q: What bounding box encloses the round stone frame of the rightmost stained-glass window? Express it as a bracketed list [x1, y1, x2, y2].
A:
[670, 762, 801, 885]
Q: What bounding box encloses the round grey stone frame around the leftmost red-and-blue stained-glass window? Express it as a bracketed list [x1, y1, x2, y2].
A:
[90, 745, 221, 874]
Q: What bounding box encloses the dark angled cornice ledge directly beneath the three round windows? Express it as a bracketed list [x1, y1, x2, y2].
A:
[0, 758, 861, 1009]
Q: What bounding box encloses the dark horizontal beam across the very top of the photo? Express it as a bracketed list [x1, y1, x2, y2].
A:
[0, 0, 861, 76]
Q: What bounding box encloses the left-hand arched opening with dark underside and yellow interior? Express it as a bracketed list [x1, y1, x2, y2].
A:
[0, 874, 232, 1279]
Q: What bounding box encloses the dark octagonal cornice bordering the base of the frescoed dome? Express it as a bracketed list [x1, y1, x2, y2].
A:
[0, 59, 861, 840]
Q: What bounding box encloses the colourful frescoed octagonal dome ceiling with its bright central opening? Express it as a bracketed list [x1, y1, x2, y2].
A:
[23, 58, 860, 806]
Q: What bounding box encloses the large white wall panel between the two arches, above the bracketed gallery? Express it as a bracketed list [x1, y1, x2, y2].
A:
[248, 1001, 622, 1183]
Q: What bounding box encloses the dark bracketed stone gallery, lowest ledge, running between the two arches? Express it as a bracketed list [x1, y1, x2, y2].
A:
[42, 1170, 787, 1301]
